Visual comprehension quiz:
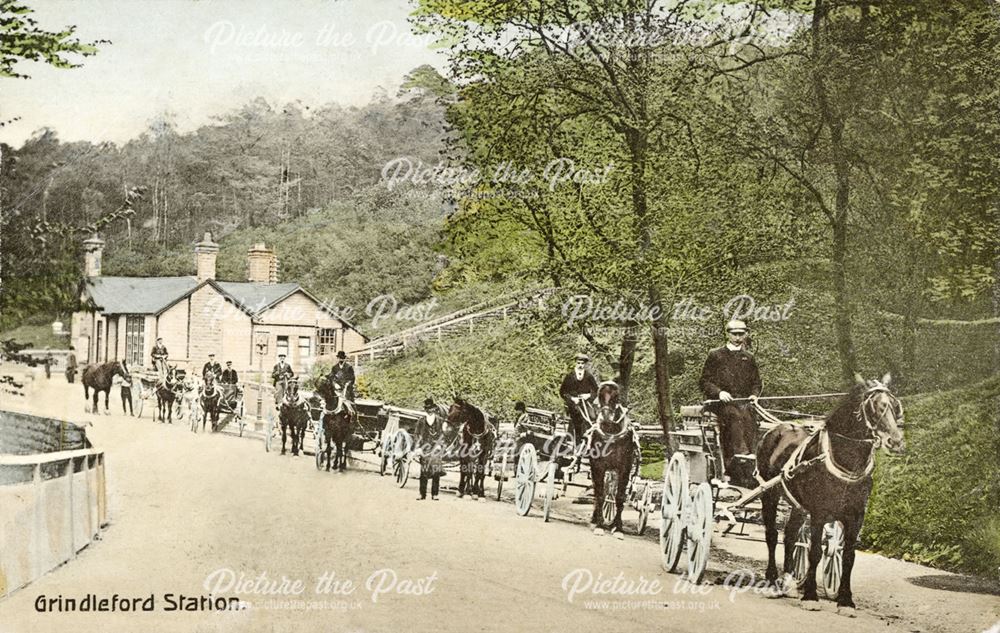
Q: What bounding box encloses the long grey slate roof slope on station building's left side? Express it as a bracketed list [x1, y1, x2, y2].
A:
[84, 276, 198, 314]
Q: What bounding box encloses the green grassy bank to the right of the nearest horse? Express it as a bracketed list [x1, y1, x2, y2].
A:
[862, 377, 1000, 573]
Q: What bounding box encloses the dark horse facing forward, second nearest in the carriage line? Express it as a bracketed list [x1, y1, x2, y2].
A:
[578, 381, 639, 539]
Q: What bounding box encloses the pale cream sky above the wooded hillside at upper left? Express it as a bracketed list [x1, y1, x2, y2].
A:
[0, 0, 445, 147]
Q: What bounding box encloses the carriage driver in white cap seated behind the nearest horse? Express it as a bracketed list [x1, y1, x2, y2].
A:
[698, 319, 761, 482]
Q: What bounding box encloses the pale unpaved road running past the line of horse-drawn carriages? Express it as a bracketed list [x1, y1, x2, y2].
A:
[0, 370, 1000, 633]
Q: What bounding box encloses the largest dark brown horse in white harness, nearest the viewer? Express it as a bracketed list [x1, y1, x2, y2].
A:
[757, 374, 906, 616]
